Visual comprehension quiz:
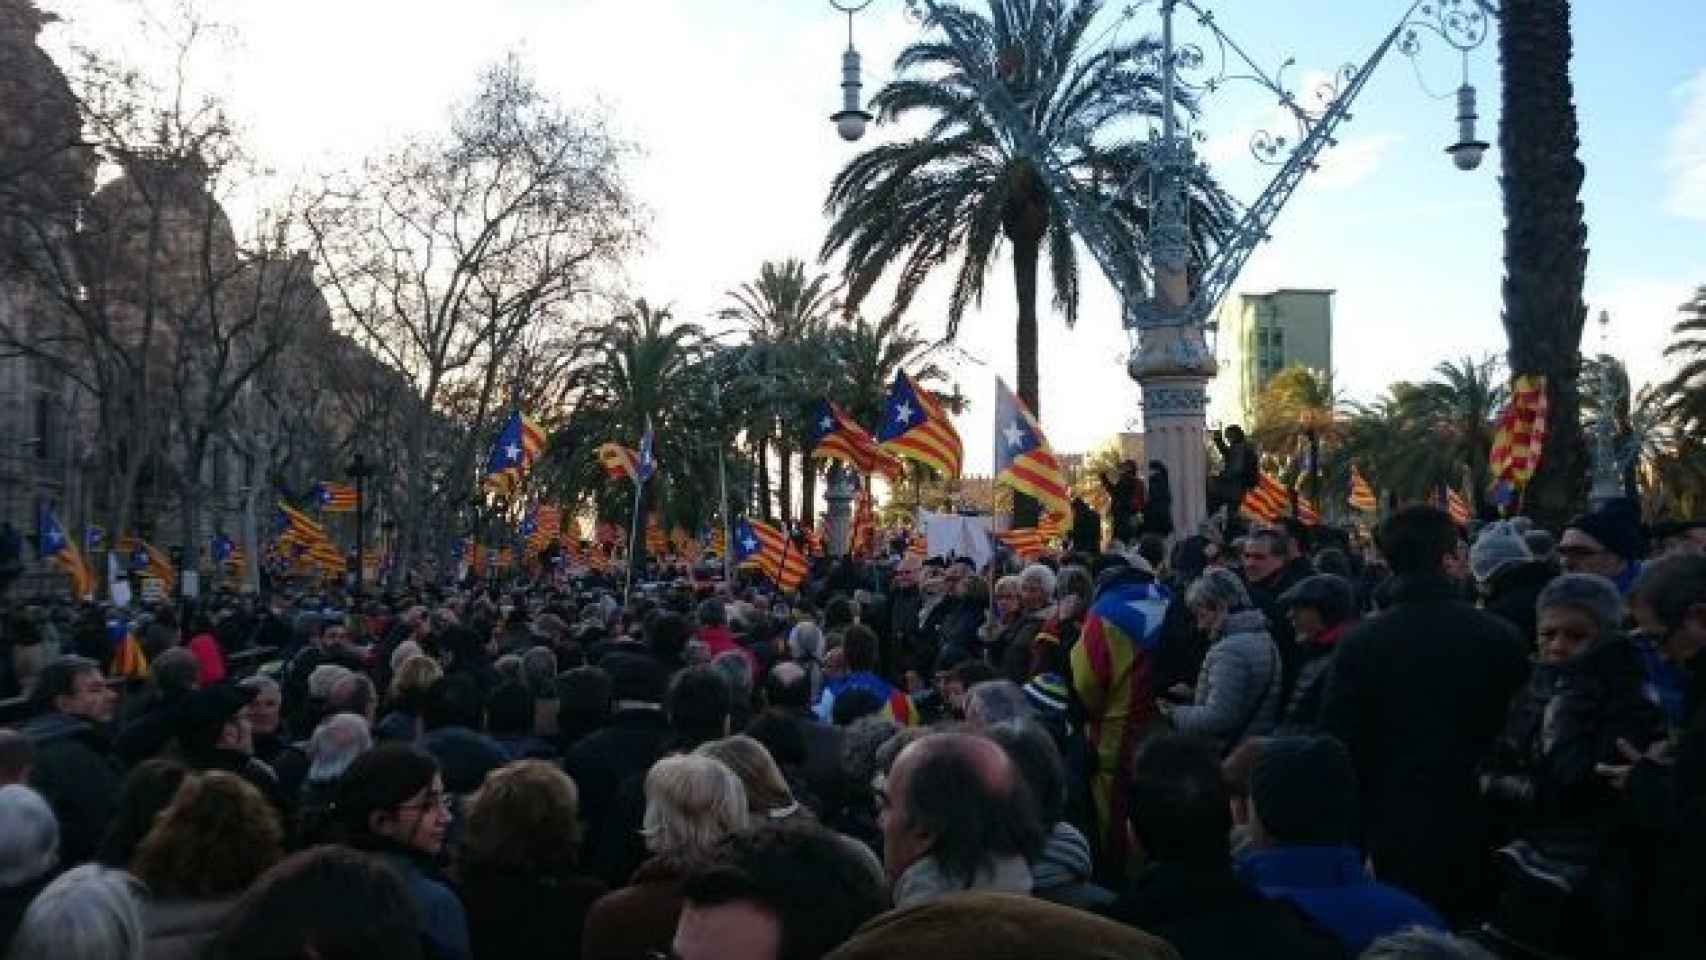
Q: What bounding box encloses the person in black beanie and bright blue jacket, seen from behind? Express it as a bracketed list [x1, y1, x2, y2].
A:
[1237, 737, 1447, 957]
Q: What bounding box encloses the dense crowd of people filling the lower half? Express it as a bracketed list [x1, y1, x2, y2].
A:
[0, 494, 1706, 960]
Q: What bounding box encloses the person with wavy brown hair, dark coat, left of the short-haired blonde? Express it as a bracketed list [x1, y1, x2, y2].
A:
[459, 760, 604, 960]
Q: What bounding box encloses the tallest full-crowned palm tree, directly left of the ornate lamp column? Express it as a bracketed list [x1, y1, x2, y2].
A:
[821, 0, 1230, 522]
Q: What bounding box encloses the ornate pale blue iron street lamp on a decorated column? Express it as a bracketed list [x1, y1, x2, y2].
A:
[831, 0, 1498, 530]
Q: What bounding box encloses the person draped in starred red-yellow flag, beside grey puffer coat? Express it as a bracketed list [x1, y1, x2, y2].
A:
[1070, 564, 1172, 865]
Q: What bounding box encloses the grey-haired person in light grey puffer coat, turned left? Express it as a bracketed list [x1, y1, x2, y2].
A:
[1160, 570, 1285, 750]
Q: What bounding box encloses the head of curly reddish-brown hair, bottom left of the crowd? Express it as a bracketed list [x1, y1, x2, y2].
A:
[130, 771, 283, 960]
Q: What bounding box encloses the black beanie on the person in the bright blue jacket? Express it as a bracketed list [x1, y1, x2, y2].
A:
[1250, 737, 1356, 846]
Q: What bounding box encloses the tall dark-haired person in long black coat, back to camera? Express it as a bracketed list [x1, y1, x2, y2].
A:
[1320, 506, 1529, 924]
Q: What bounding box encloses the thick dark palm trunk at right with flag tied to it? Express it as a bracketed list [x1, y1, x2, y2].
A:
[1500, 0, 1588, 529]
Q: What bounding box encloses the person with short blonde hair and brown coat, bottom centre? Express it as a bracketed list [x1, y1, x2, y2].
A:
[580, 754, 749, 960]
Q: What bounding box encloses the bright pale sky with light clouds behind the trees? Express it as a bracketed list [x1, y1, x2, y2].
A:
[43, 0, 1706, 474]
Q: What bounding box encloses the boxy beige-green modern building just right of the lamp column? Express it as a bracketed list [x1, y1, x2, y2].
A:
[1208, 288, 1334, 430]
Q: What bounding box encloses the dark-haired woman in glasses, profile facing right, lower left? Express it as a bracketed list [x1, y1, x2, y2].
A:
[334, 743, 473, 960]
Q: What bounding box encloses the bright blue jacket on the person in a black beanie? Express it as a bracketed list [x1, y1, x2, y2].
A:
[1239, 846, 1447, 957]
